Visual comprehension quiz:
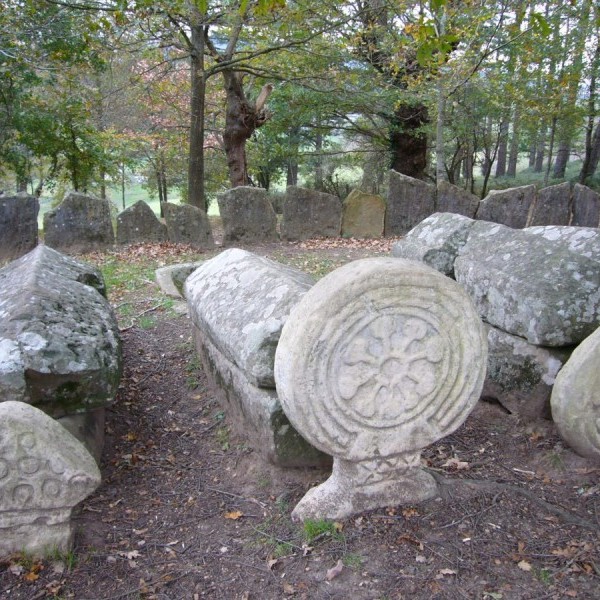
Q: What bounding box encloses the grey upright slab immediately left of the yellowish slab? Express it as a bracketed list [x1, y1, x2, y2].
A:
[281, 186, 342, 240]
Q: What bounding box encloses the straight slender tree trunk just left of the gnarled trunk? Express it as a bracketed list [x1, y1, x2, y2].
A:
[188, 25, 207, 211]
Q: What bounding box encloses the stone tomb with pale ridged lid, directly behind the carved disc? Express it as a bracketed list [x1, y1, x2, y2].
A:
[185, 248, 331, 467]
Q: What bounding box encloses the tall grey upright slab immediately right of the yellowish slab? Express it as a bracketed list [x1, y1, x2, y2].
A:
[384, 171, 435, 236]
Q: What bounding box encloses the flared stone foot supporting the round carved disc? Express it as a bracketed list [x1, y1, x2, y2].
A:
[292, 453, 438, 521]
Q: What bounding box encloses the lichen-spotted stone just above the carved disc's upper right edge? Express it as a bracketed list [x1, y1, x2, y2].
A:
[392, 213, 475, 278]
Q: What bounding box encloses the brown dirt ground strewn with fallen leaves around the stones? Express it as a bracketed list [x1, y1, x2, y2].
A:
[0, 240, 600, 600]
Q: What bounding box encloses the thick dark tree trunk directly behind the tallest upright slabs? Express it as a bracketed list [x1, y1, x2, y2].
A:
[390, 104, 429, 179]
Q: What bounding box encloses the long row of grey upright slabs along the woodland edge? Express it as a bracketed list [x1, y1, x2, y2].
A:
[0, 177, 600, 260]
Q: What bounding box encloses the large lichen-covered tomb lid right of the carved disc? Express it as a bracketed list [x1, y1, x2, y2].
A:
[454, 221, 600, 347]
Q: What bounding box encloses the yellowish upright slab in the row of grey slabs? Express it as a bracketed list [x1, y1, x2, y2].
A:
[342, 190, 385, 238]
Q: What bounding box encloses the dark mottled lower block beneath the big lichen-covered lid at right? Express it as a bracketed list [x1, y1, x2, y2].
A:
[482, 325, 571, 419]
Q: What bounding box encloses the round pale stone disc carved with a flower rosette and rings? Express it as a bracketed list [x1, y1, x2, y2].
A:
[275, 258, 487, 461]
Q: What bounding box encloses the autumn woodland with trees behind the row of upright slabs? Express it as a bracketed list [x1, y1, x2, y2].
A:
[0, 0, 600, 220]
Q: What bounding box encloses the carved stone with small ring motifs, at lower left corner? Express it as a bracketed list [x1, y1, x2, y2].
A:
[0, 401, 100, 555]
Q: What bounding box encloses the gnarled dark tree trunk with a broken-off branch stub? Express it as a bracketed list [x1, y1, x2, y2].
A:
[222, 69, 273, 187]
